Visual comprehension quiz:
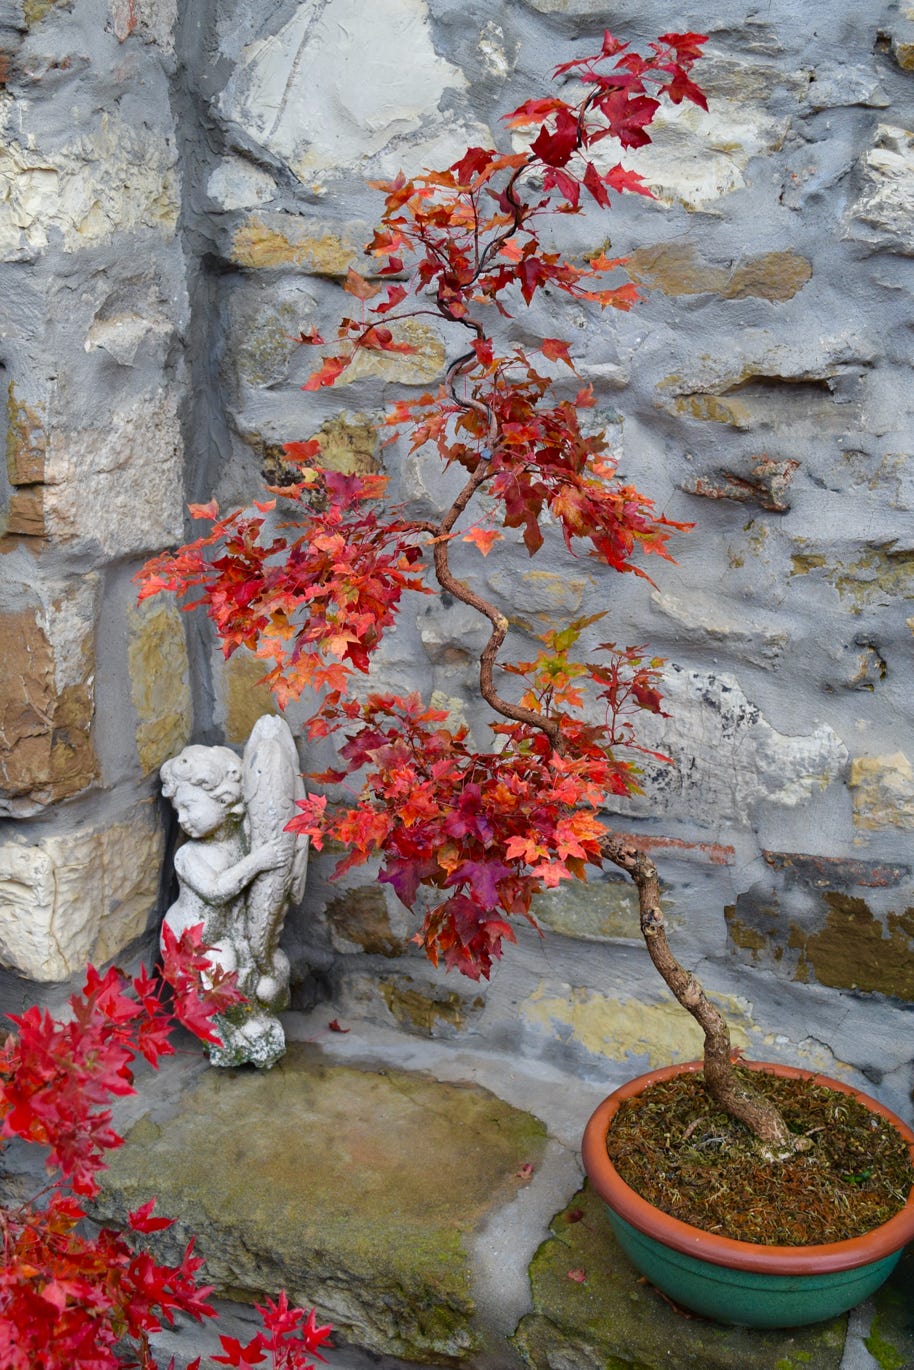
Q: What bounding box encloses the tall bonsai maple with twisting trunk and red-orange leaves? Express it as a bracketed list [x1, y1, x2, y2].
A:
[135, 33, 792, 1151]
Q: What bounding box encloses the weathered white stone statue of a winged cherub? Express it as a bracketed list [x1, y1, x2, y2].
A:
[160, 717, 308, 1069]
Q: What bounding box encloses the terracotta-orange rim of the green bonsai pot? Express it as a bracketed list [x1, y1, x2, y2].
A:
[582, 1060, 914, 1275]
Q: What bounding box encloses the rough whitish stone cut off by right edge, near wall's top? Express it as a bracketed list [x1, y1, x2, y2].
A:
[844, 123, 914, 256]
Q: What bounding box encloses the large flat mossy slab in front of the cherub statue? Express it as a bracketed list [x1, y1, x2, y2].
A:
[100, 1044, 545, 1365]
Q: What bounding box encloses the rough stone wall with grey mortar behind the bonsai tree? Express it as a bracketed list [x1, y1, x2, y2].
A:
[0, 0, 914, 1110]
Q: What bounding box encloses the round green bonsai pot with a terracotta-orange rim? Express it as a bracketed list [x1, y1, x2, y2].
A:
[582, 1060, 914, 1328]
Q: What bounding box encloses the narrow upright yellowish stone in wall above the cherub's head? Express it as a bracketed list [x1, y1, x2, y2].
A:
[127, 599, 193, 775]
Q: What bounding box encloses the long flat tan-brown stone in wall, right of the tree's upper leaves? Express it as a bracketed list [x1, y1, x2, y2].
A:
[625, 241, 813, 303]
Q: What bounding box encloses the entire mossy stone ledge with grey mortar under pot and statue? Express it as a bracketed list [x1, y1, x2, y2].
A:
[87, 1008, 914, 1370]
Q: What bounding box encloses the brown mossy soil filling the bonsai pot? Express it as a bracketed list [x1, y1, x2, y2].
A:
[607, 1071, 914, 1247]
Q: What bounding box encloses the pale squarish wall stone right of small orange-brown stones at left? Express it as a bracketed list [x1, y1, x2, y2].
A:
[44, 385, 184, 556]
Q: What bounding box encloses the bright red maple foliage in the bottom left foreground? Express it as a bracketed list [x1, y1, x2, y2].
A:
[0, 926, 329, 1370]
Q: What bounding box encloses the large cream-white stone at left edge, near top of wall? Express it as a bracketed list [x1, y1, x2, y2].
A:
[0, 105, 178, 262]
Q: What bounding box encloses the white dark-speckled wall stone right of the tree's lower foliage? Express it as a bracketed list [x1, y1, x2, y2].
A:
[615, 666, 848, 826]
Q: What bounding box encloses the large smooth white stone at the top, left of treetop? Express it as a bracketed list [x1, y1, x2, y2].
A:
[219, 0, 489, 188]
